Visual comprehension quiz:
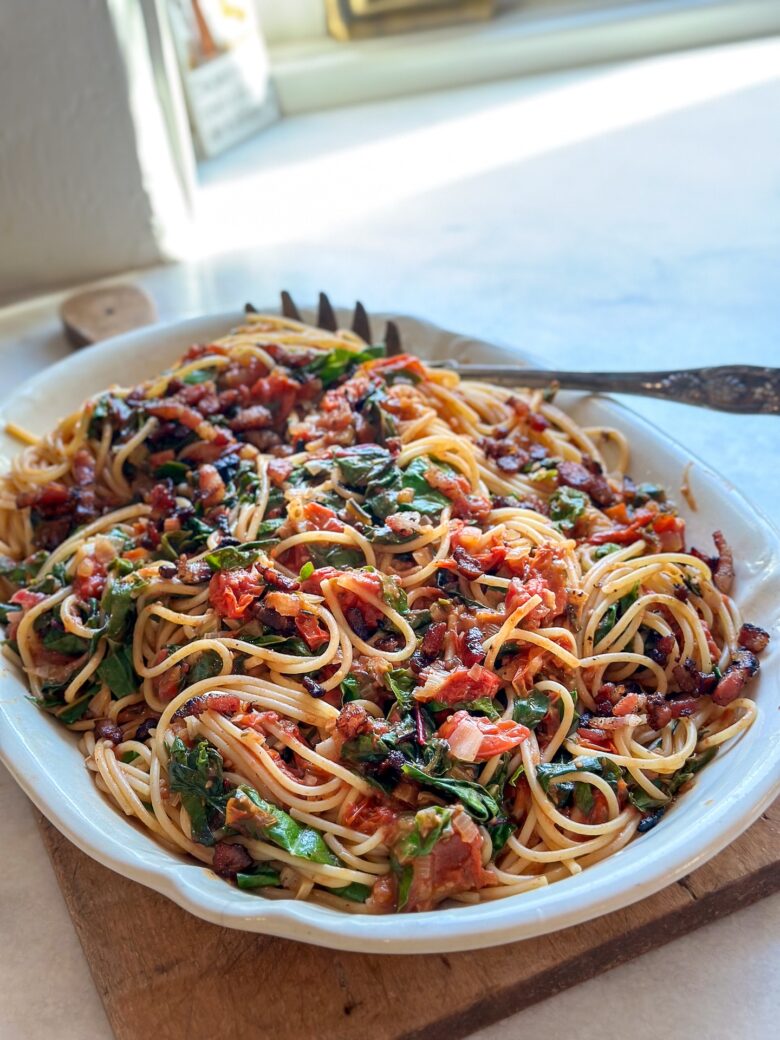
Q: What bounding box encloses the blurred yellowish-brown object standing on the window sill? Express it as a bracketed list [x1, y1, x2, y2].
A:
[326, 0, 495, 40]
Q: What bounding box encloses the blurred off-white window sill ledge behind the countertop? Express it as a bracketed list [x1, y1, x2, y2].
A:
[270, 0, 780, 115]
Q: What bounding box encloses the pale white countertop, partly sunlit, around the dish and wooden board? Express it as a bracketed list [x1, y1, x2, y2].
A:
[0, 40, 780, 1040]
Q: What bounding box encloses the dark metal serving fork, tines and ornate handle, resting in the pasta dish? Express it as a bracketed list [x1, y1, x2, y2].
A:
[257, 292, 780, 415]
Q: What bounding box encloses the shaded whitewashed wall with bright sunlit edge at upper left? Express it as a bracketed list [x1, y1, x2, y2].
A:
[0, 0, 189, 300]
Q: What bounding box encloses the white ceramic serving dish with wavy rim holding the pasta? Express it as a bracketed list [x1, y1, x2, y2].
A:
[0, 312, 780, 953]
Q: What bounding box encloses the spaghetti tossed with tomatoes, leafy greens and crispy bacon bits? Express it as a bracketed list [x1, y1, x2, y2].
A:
[0, 313, 769, 913]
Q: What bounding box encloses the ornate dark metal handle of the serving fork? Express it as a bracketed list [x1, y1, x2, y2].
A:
[428, 361, 780, 415]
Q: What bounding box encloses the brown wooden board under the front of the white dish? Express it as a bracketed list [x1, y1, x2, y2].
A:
[40, 802, 780, 1040]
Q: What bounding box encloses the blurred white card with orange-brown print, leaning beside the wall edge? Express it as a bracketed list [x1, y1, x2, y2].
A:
[168, 0, 279, 158]
